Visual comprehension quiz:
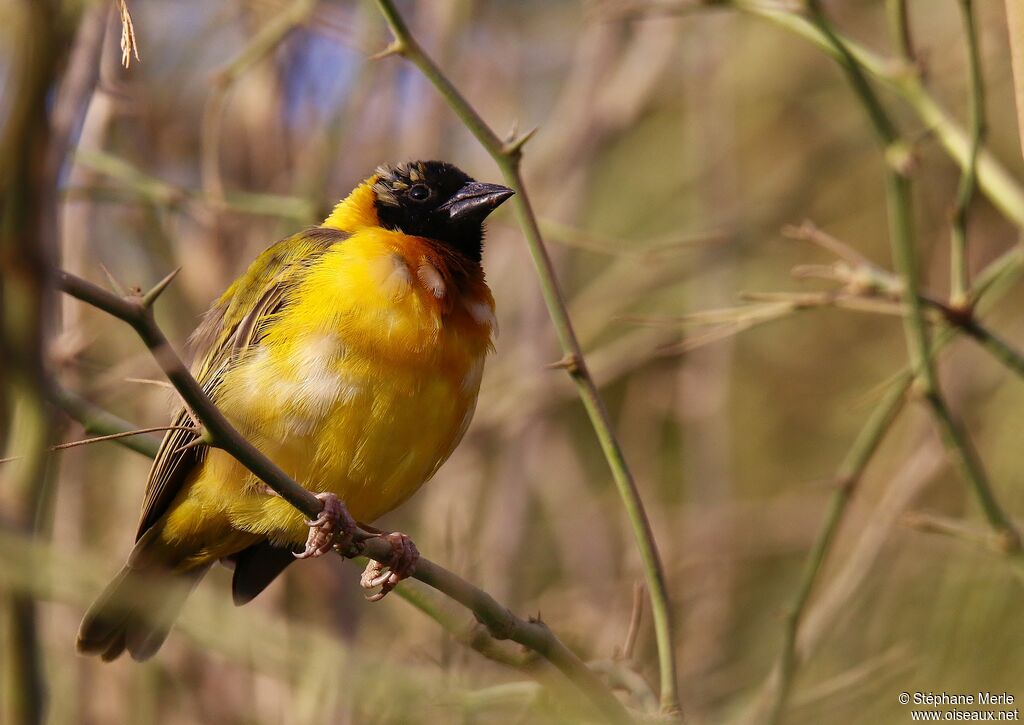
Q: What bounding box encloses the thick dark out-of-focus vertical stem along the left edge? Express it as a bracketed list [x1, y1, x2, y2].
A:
[0, 2, 70, 723]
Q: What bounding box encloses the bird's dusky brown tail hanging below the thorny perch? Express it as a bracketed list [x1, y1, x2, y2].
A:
[76, 542, 209, 662]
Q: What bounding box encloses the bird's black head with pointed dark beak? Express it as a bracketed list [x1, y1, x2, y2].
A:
[374, 161, 513, 262]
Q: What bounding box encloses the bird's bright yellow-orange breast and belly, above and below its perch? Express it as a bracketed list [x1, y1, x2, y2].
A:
[206, 227, 496, 541]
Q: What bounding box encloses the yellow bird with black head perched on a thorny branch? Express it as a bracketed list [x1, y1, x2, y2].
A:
[77, 161, 513, 662]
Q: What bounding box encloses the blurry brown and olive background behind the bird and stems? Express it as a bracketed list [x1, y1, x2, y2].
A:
[0, 0, 1024, 723]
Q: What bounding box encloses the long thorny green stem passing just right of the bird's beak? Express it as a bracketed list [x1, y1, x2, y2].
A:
[377, 0, 679, 714]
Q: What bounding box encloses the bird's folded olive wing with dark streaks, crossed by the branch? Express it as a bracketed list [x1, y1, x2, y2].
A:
[136, 226, 348, 541]
